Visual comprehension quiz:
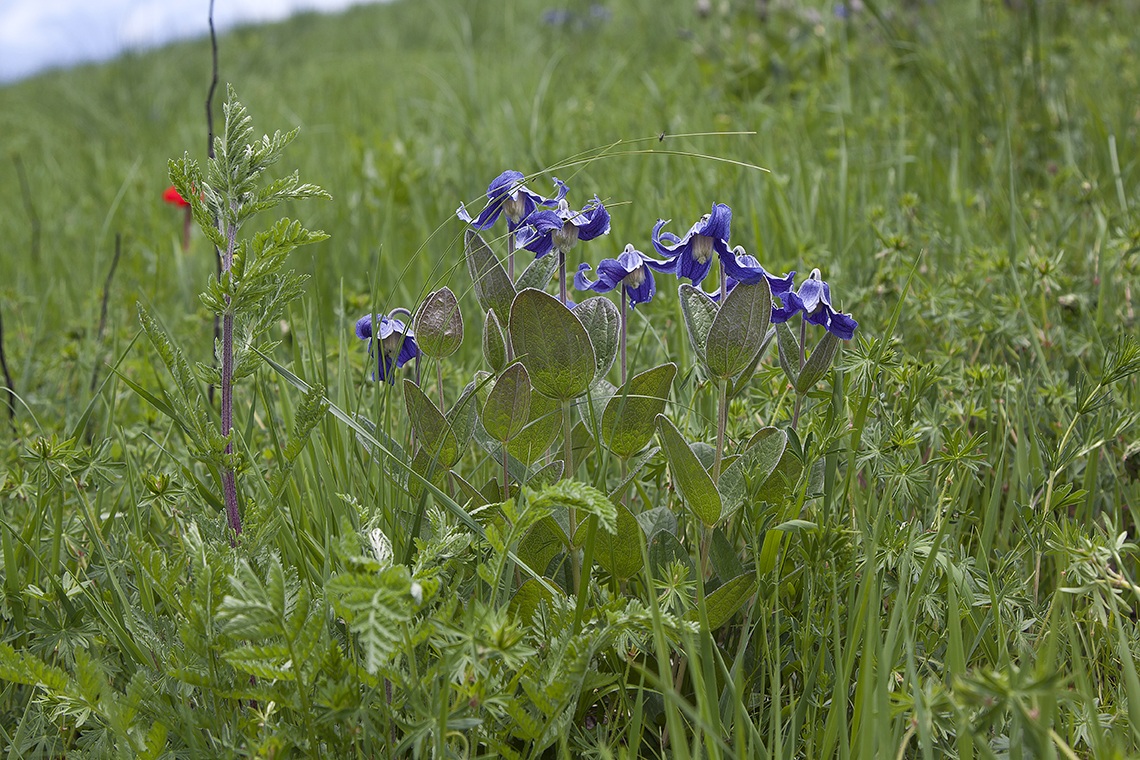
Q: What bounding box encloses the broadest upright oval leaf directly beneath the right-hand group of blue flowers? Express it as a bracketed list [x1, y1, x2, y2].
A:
[705, 279, 772, 379]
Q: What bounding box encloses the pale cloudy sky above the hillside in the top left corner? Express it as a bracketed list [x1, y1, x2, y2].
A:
[0, 0, 381, 82]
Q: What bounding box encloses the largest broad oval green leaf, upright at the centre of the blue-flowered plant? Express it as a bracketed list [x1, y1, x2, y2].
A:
[510, 288, 596, 401]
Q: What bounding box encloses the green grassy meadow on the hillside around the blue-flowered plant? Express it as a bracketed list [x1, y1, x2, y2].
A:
[0, 0, 1140, 758]
